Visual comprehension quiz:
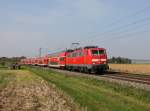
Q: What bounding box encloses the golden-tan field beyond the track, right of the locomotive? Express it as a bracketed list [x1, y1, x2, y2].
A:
[109, 64, 150, 75]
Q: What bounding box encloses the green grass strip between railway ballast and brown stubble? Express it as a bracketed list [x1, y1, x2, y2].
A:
[27, 68, 150, 111]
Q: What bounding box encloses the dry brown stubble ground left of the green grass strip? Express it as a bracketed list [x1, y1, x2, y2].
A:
[0, 71, 74, 111]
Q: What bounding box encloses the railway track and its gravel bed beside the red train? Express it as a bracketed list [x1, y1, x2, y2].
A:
[31, 68, 150, 90]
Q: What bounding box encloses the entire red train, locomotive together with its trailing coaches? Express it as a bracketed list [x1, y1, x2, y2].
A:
[21, 46, 109, 73]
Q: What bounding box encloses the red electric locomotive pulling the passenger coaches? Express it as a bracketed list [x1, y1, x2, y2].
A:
[66, 46, 108, 73]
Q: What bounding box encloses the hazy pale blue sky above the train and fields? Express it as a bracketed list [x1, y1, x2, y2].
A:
[0, 0, 150, 59]
